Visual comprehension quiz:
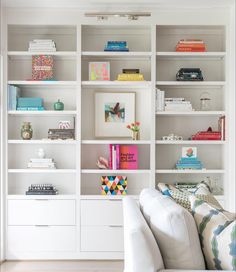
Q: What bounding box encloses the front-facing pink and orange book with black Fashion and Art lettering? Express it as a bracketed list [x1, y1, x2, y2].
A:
[120, 145, 138, 169]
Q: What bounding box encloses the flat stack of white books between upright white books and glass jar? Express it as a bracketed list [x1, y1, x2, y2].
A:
[165, 97, 193, 111]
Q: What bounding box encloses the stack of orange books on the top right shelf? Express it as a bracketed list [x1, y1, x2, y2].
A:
[176, 39, 206, 52]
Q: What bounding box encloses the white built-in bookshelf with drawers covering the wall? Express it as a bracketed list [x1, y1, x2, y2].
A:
[2, 23, 235, 259]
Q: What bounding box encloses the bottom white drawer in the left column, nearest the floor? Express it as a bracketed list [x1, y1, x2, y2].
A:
[8, 226, 76, 255]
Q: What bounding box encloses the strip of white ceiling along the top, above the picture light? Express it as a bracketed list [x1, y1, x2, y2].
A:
[2, 0, 235, 10]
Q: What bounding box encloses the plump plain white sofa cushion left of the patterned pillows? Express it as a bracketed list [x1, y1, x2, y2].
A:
[140, 189, 205, 270]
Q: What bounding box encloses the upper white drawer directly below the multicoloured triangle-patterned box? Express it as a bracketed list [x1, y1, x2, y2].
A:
[81, 200, 123, 226]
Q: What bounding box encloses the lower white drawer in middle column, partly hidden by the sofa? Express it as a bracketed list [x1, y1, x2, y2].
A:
[81, 226, 124, 252]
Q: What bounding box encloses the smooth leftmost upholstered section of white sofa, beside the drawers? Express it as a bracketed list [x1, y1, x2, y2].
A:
[123, 197, 164, 272]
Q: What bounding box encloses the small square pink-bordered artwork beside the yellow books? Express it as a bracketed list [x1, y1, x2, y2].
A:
[89, 62, 110, 81]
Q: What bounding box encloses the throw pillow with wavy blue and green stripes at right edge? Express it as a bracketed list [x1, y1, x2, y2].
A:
[189, 196, 236, 270]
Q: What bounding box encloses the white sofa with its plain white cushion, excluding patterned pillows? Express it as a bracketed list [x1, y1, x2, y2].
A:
[123, 189, 228, 272]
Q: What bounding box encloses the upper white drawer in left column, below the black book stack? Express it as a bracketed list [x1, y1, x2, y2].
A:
[8, 199, 75, 226]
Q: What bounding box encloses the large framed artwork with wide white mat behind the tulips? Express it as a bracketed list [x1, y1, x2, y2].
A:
[95, 92, 135, 137]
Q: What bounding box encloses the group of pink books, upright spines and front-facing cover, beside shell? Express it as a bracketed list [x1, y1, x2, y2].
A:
[109, 144, 138, 170]
